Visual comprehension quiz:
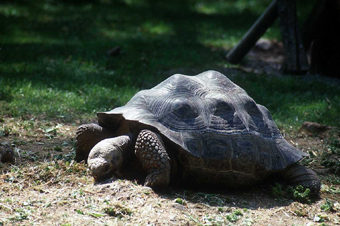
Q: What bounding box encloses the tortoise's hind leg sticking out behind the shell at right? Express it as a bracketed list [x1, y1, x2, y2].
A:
[282, 163, 321, 194]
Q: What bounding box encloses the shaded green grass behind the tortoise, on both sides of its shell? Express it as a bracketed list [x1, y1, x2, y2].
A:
[0, 0, 340, 129]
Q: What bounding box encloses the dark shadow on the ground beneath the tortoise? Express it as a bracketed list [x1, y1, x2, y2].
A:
[95, 171, 294, 210]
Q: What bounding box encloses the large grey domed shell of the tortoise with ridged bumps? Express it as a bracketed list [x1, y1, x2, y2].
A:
[98, 71, 306, 185]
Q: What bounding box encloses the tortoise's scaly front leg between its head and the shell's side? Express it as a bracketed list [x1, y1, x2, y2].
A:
[135, 130, 170, 188]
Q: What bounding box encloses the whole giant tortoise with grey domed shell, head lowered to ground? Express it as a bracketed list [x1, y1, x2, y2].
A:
[76, 71, 320, 193]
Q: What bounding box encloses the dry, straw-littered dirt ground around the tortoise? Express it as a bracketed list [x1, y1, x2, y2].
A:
[0, 42, 340, 226]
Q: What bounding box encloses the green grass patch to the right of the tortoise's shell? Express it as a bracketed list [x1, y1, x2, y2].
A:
[235, 75, 340, 129]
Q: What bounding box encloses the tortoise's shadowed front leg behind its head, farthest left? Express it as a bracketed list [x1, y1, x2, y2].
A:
[75, 123, 114, 162]
